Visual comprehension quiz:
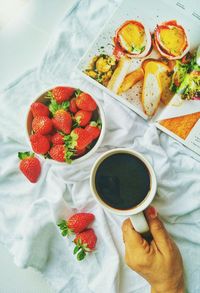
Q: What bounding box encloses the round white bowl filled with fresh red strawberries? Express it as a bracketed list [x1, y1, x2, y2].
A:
[27, 86, 105, 163]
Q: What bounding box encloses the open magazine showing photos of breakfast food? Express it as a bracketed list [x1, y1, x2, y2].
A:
[77, 0, 200, 154]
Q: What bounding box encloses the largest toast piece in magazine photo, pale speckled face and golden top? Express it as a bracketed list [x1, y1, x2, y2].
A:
[142, 60, 168, 116]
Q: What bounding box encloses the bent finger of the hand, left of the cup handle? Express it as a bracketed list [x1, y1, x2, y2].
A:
[122, 219, 145, 249]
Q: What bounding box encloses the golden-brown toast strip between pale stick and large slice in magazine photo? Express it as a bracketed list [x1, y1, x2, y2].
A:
[118, 68, 144, 94]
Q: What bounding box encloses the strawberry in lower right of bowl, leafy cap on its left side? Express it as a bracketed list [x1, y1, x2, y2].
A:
[69, 128, 92, 150]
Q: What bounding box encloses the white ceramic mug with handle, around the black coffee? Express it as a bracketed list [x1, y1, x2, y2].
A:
[90, 148, 157, 233]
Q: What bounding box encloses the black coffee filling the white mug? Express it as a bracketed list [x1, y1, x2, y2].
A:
[95, 153, 150, 210]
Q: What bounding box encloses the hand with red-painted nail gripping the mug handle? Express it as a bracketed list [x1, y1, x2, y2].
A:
[122, 207, 184, 293]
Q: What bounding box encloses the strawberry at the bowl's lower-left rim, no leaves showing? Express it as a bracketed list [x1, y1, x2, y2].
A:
[30, 133, 50, 154]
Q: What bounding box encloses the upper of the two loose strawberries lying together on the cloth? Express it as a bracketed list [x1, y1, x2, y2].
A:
[58, 213, 95, 236]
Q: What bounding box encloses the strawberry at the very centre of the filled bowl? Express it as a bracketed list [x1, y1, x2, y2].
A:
[52, 109, 72, 134]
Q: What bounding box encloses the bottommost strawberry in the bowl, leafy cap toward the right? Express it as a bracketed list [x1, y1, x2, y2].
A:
[49, 144, 73, 163]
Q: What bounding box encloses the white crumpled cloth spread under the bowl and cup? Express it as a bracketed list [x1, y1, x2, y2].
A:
[0, 0, 200, 293]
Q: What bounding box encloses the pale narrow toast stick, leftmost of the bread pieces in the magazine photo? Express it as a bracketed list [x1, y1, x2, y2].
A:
[107, 57, 130, 94]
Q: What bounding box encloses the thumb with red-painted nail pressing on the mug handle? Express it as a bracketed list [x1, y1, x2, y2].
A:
[145, 206, 171, 252]
